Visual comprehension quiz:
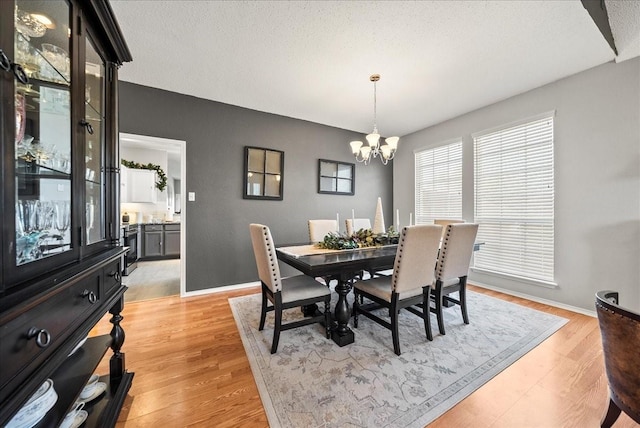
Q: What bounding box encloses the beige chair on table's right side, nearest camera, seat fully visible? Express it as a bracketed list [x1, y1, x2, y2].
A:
[353, 225, 442, 355]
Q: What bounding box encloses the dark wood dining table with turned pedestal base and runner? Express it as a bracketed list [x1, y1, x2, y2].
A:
[276, 242, 483, 346]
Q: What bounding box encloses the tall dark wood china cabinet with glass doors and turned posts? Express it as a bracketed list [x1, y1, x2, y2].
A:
[0, 0, 133, 427]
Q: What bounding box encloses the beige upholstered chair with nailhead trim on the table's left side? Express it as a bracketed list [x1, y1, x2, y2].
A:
[249, 224, 331, 354]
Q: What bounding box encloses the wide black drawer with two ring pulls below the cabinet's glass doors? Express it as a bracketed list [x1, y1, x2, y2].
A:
[0, 270, 102, 401]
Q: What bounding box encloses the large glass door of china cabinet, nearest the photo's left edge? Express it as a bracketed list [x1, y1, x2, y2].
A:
[14, 0, 73, 266]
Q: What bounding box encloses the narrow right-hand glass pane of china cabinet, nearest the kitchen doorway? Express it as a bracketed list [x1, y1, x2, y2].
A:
[84, 37, 106, 244]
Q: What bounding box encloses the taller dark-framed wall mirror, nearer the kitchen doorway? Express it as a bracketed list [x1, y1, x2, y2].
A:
[243, 146, 284, 201]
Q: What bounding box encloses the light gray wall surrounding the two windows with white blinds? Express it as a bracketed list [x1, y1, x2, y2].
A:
[393, 58, 640, 311]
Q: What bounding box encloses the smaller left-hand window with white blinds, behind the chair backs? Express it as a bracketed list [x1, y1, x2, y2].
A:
[415, 140, 462, 224]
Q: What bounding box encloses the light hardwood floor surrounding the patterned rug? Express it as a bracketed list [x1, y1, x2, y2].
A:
[92, 286, 638, 428]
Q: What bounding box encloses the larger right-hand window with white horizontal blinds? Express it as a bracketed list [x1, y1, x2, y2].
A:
[473, 112, 554, 283]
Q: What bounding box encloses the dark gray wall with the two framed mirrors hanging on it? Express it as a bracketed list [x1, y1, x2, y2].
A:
[120, 82, 393, 292]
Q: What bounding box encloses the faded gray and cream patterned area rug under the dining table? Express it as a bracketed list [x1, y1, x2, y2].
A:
[229, 292, 567, 428]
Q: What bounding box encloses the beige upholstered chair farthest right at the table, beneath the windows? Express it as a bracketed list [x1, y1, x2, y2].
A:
[431, 223, 478, 335]
